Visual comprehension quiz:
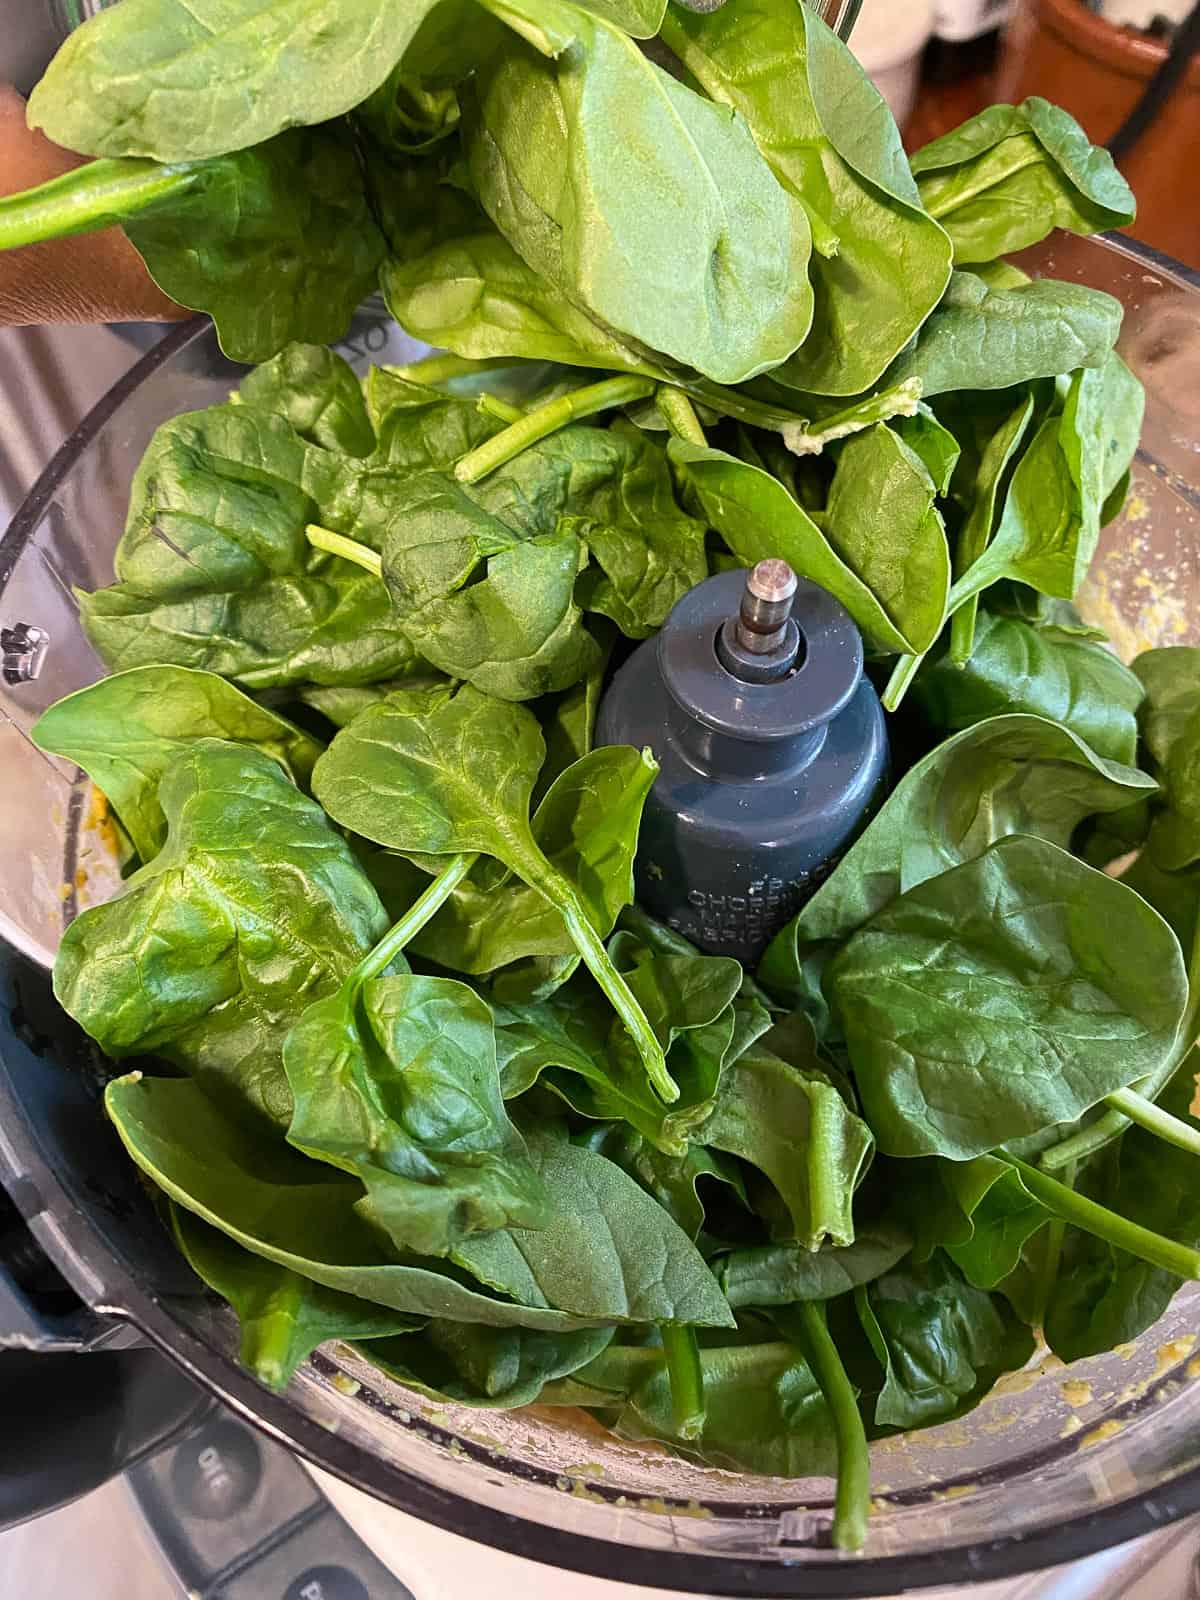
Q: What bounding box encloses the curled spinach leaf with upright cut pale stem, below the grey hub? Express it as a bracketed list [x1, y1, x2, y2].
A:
[696, 1034, 874, 1251]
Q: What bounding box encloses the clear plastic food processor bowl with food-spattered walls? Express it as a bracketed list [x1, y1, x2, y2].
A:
[0, 237, 1200, 1595]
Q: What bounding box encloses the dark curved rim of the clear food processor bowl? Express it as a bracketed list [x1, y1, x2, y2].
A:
[0, 243, 1200, 1600]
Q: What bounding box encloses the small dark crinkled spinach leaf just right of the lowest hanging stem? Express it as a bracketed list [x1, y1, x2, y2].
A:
[854, 1254, 1034, 1427]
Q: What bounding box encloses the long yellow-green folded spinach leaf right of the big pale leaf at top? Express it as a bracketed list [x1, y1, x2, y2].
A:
[662, 0, 950, 395]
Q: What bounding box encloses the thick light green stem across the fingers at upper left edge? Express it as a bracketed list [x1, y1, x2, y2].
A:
[0, 158, 203, 250]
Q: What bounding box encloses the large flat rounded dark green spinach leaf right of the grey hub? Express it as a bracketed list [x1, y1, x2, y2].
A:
[826, 835, 1187, 1160]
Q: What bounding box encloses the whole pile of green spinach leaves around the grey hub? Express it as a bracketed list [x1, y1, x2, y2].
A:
[18, 0, 1200, 1549]
